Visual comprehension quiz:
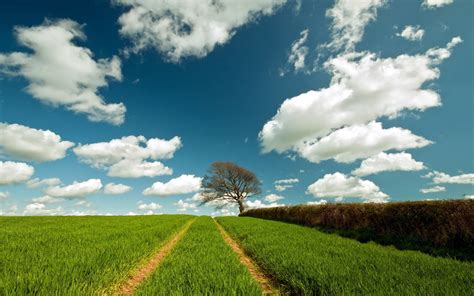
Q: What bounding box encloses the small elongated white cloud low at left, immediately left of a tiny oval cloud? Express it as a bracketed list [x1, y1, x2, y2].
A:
[44, 179, 102, 198]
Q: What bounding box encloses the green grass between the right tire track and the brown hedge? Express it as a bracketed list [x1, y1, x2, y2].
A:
[218, 217, 474, 295]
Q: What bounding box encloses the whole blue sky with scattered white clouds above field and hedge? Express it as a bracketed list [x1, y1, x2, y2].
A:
[0, 0, 474, 215]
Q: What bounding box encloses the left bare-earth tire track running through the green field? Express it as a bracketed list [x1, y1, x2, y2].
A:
[114, 218, 196, 296]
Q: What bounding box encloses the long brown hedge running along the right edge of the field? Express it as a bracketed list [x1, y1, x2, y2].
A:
[241, 200, 474, 261]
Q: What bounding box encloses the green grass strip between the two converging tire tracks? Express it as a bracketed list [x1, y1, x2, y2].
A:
[137, 217, 261, 295]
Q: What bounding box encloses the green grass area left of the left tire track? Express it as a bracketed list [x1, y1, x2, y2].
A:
[0, 215, 192, 295]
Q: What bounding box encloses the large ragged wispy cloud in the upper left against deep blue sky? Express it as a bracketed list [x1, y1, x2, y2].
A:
[0, 19, 126, 125]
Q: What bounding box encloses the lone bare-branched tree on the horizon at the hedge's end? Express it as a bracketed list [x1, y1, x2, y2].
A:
[201, 162, 261, 213]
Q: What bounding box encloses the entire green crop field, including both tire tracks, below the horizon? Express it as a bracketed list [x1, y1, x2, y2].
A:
[0, 215, 474, 295]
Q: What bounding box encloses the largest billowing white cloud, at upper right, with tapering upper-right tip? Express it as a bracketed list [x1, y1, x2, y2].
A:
[259, 37, 460, 157]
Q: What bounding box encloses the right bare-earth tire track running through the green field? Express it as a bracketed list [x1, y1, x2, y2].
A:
[213, 219, 282, 295]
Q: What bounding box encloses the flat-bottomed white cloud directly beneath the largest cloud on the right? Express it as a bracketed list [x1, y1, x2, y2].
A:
[297, 122, 432, 163]
